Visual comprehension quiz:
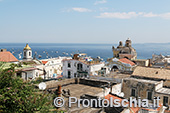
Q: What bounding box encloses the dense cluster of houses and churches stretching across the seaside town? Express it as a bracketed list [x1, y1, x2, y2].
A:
[0, 39, 170, 113]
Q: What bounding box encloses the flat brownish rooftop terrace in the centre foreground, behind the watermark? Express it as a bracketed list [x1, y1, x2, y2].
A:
[59, 84, 103, 113]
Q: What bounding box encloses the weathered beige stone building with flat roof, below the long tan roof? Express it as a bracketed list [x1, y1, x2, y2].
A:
[122, 78, 163, 102]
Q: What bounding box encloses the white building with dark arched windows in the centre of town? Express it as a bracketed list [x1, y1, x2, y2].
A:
[63, 54, 104, 78]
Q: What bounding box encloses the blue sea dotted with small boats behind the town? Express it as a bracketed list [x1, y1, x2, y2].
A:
[0, 43, 170, 61]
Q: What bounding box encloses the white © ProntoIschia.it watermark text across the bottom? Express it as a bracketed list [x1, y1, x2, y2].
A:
[54, 97, 160, 108]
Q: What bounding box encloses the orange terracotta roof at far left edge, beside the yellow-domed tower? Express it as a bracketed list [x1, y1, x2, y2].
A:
[0, 51, 18, 62]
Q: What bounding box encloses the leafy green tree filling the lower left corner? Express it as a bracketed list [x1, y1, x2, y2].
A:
[0, 63, 52, 113]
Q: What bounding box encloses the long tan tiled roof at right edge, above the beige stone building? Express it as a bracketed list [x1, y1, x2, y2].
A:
[132, 66, 170, 80]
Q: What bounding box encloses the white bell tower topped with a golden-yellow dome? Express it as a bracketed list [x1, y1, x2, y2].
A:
[23, 44, 32, 61]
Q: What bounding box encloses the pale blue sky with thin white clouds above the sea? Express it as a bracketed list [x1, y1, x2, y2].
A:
[0, 0, 170, 44]
